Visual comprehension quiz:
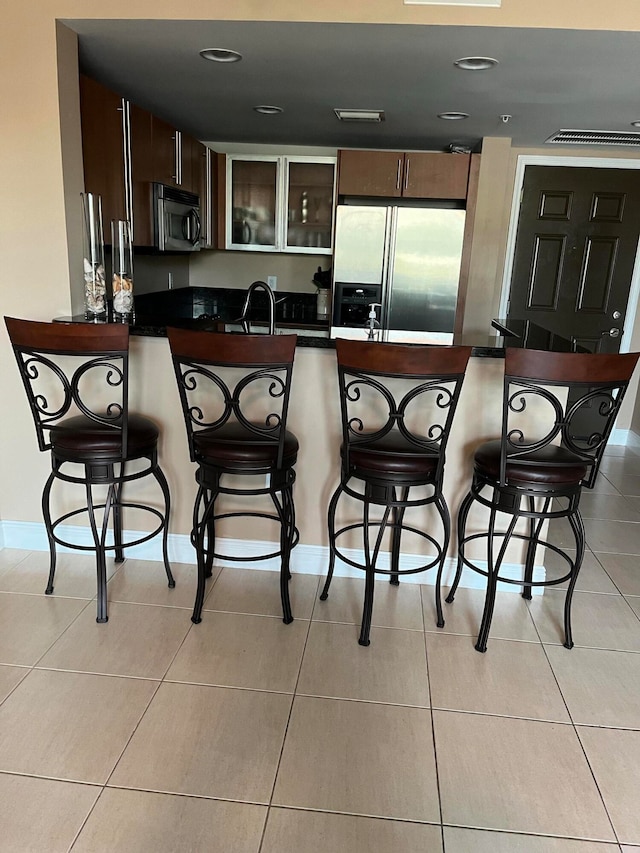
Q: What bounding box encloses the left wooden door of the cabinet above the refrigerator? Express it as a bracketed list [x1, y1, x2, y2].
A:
[338, 150, 404, 198]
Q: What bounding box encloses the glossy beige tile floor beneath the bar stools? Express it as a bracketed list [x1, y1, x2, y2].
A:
[0, 447, 640, 853]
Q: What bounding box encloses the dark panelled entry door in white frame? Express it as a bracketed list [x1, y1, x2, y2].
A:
[508, 166, 640, 352]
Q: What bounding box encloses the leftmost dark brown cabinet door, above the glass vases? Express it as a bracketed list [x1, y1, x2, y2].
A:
[80, 75, 126, 231]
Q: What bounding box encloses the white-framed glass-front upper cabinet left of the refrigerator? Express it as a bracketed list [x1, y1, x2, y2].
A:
[225, 154, 336, 254]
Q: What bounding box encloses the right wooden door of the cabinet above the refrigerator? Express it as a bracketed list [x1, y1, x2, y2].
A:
[402, 151, 471, 199]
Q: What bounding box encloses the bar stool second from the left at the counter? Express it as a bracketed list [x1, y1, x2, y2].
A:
[167, 329, 300, 624]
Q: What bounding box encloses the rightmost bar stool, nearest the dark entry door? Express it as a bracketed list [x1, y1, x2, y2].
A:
[446, 349, 640, 652]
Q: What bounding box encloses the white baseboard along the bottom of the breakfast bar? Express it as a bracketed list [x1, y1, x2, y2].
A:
[0, 521, 545, 594]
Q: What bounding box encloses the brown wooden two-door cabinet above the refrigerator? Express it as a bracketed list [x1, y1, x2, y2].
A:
[338, 150, 471, 199]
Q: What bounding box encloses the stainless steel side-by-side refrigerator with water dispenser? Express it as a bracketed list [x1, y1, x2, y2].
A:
[331, 204, 465, 344]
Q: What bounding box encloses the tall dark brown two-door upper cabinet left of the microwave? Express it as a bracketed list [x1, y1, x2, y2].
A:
[80, 75, 153, 246]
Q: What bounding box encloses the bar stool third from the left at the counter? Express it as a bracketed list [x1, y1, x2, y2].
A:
[320, 340, 471, 646]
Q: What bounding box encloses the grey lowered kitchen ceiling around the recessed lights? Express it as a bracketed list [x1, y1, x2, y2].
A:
[64, 20, 640, 152]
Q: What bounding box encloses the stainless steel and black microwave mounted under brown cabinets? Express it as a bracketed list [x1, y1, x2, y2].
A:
[153, 183, 201, 252]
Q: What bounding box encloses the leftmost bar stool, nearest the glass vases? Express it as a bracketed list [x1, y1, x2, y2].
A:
[5, 317, 175, 622]
